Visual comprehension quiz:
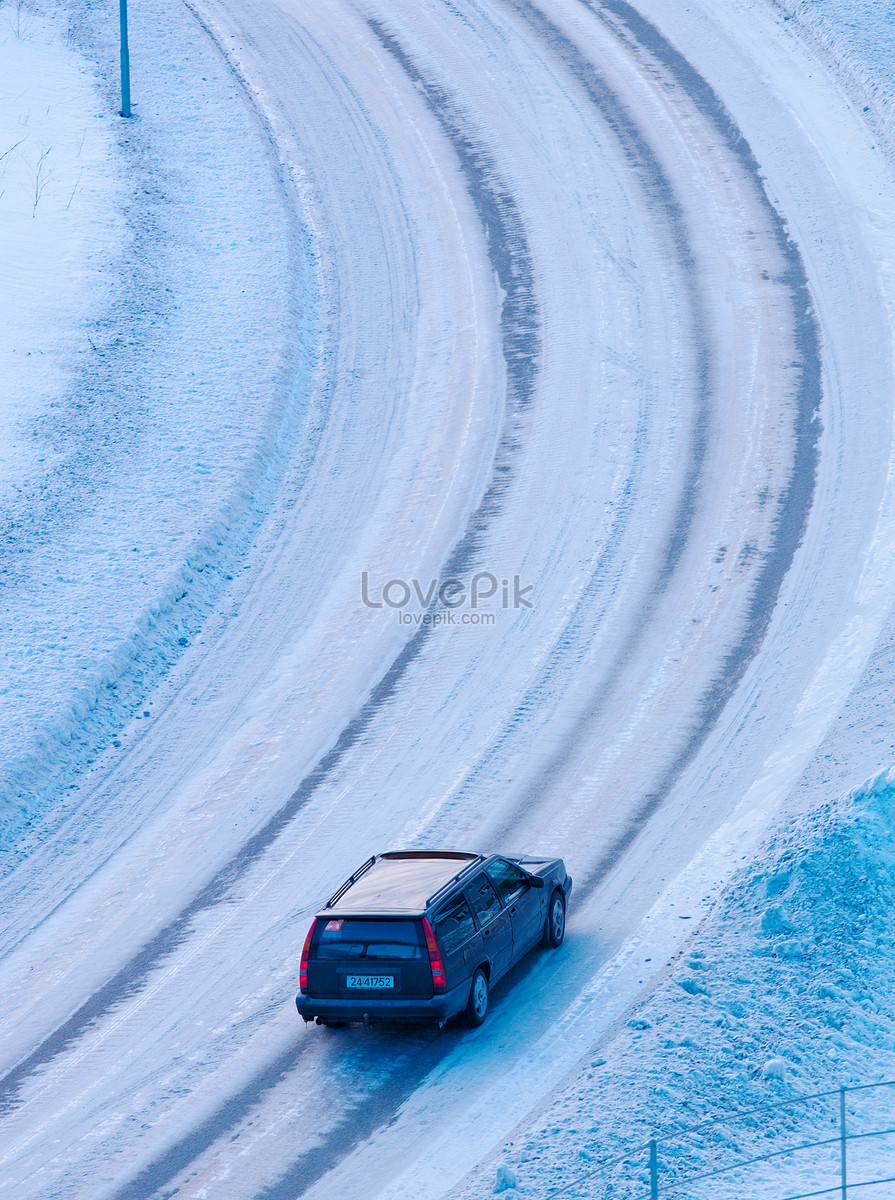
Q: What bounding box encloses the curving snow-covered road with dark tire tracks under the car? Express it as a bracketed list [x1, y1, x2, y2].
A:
[0, 0, 895, 1200]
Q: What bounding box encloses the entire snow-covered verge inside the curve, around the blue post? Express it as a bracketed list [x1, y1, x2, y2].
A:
[0, 2, 313, 860]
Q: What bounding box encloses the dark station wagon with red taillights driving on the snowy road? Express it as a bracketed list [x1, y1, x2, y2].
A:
[295, 850, 572, 1025]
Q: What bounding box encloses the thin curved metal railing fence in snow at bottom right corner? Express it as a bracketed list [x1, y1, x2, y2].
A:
[547, 1080, 895, 1200]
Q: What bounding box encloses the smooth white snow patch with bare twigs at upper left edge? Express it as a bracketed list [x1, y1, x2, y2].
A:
[0, 5, 126, 501]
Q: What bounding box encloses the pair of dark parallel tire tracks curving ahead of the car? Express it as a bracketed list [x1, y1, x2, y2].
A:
[491, 0, 822, 898]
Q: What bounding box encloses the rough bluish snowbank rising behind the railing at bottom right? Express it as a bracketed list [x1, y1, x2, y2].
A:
[457, 772, 895, 1200]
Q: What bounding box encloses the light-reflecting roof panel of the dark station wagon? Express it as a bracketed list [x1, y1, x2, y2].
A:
[324, 850, 486, 916]
